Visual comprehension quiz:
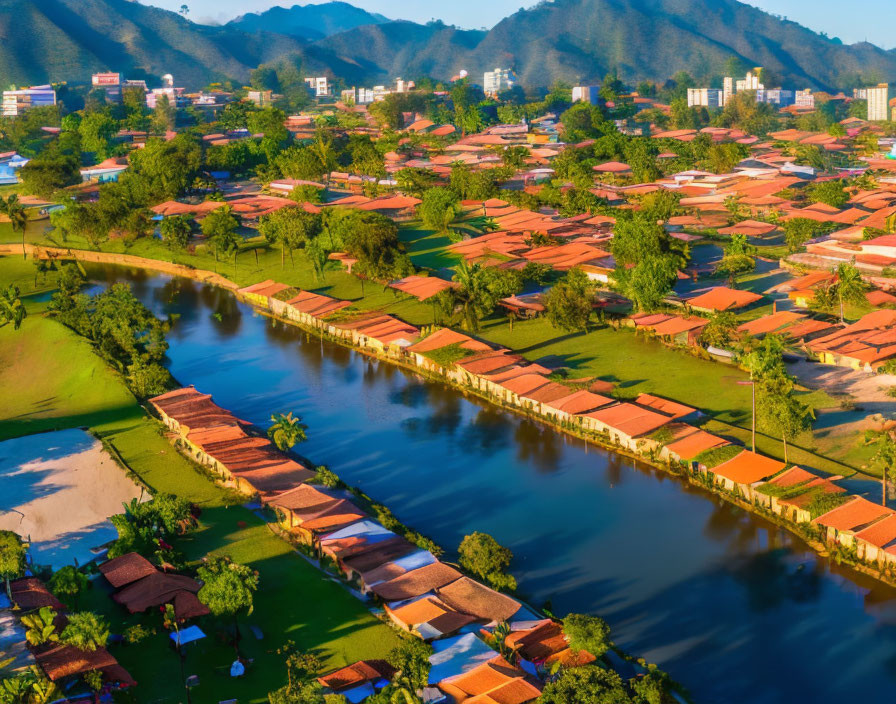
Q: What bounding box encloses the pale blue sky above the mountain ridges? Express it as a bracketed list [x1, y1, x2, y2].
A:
[142, 0, 896, 49]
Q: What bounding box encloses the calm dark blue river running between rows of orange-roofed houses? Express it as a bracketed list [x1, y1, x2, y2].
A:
[91, 268, 896, 704]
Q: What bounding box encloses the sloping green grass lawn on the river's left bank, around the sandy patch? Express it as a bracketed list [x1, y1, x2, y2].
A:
[0, 310, 397, 702]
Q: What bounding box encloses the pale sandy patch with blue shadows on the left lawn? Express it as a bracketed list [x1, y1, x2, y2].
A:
[0, 430, 148, 568]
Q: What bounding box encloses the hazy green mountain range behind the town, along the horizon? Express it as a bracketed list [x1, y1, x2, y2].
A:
[0, 0, 896, 90]
